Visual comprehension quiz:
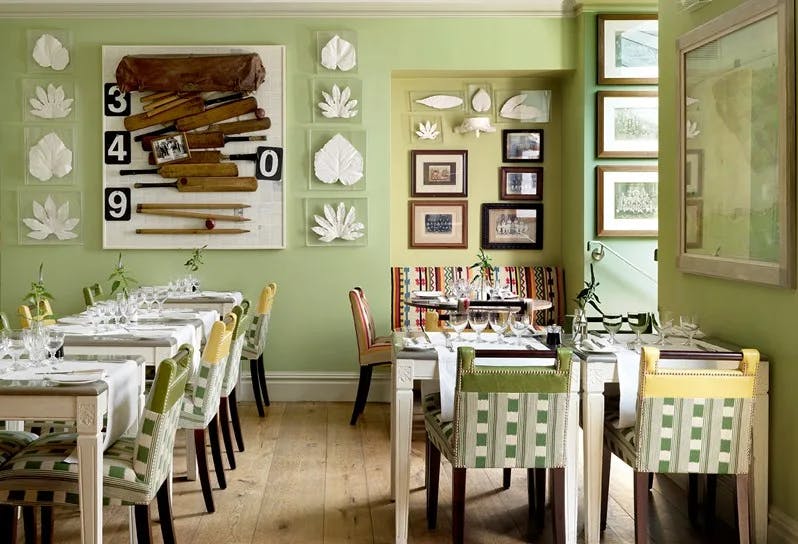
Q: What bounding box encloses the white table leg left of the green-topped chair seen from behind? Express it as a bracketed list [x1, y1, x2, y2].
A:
[391, 361, 413, 544]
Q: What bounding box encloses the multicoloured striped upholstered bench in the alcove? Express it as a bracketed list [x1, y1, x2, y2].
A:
[391, 266, 565, 330]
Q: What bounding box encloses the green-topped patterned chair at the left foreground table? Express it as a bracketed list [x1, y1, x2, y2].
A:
[0, 345, 192, 543]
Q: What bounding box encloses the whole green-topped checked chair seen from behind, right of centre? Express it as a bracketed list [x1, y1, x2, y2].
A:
[424, 347, 577, 544]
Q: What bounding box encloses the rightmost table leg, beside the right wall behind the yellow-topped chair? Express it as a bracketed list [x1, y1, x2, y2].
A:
[750, 393, 770, 544]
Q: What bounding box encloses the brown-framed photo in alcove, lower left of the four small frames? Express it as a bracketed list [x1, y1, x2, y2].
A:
[409, 200, 468, 249]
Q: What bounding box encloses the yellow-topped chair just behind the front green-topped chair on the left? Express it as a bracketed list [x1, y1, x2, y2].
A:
[179, 312, 237, 512]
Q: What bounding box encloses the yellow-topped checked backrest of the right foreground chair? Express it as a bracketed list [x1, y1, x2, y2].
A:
[630, 347, 759, 474]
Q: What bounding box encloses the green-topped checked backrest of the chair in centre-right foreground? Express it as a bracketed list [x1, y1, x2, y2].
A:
[439, 347, 575, 468]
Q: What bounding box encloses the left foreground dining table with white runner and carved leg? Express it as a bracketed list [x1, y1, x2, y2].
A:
[0, 355, 144, 544]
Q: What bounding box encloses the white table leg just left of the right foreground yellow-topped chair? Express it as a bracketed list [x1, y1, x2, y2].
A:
[582, 388, 604, 544]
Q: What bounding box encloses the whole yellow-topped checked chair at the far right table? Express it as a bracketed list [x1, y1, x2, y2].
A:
[601, 347, 759, 544]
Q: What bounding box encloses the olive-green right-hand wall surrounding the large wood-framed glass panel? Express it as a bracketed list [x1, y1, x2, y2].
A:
[659, 0, 798, 519]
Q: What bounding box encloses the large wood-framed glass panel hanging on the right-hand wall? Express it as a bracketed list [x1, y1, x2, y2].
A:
[678, 0, 795, 287]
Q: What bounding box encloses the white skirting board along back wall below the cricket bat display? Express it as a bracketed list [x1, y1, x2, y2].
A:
[236, 364, 391, 402]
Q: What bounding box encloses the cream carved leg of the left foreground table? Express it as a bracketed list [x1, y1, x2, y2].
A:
[77, 393, 108, 544]
